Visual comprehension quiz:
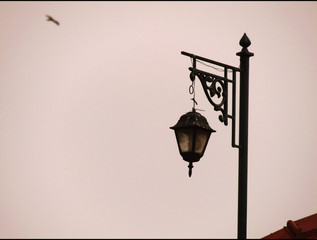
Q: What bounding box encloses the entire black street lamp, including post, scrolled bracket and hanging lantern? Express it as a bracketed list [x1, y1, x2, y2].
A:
[171, 34, 254, 239]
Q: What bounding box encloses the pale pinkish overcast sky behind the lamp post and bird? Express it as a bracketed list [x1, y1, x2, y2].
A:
[0, 1, 317, 238]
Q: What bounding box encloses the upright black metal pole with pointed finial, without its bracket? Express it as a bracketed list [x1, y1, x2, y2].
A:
[237, 34, 254, 239]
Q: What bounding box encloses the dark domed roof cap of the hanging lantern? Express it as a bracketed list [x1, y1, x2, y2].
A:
[171, 108, 216, 132]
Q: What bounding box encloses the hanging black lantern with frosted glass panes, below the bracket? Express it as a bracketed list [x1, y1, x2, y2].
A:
[170, 108, 216, 177]
